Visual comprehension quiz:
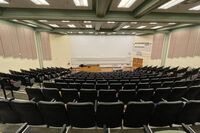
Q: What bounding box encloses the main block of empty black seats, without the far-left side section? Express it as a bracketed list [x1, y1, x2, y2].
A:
[0, 66, 200, 133]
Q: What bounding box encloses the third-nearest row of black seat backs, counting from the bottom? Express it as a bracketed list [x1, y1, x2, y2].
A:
[43, 80, 200, 90]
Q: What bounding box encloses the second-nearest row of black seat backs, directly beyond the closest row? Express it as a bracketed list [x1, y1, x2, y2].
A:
[25, 86, 200, 104]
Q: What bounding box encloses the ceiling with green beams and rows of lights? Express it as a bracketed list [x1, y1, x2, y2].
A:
[0, 0, 200, 35]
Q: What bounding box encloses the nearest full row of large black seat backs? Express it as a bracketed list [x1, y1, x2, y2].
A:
[0, 99, 200, 128]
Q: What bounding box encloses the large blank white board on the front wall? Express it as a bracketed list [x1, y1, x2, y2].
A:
[69, 35, 134, 65]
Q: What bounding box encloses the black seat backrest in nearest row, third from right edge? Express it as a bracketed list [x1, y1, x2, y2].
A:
[124, 102, 154, 127]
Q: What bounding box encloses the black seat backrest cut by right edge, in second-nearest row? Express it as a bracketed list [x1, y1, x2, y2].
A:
[184, 85, 200, 100]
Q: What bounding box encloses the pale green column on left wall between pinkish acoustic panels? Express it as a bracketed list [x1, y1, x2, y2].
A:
[35, 31, 44, 68]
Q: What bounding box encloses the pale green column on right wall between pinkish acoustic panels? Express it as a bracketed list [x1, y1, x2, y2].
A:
[161, 32, 170, 66]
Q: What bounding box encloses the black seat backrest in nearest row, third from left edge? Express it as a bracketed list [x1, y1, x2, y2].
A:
[38, 101, 69, 127]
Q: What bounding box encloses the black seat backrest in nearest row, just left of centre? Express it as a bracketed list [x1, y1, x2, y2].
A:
[67, 102, 95, 128]
